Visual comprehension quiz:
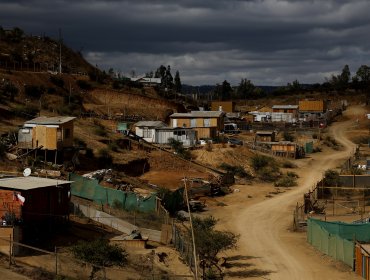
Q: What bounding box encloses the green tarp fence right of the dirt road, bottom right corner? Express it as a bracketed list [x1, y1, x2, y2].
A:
[307, 218, 370, 268]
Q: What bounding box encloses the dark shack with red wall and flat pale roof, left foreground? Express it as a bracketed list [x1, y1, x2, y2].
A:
[0, 176, 72, 241]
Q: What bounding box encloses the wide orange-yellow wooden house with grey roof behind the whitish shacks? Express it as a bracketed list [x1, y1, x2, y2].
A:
[170, 111, 225, 140]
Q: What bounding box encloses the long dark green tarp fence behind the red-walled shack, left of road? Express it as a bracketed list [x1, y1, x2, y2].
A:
[68, 173, 156, 213]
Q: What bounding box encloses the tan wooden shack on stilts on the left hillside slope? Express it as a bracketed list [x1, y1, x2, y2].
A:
[18, 116, 75, 150]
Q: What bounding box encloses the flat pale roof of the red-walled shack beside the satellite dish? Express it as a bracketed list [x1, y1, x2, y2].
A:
[0, 176, 72, 191]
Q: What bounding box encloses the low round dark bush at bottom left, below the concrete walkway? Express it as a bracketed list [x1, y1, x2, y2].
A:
[71, 239, 127, 279]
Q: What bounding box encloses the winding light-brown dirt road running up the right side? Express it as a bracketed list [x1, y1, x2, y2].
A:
[216, 106, 365, 280]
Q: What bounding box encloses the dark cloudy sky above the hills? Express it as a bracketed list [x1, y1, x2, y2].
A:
[0, 0, 370, 85]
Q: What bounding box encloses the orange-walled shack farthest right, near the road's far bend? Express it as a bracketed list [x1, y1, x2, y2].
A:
[299, 100, 327, 121]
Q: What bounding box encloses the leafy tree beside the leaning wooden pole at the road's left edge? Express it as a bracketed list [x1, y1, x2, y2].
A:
[189, 216, 239, 279]
